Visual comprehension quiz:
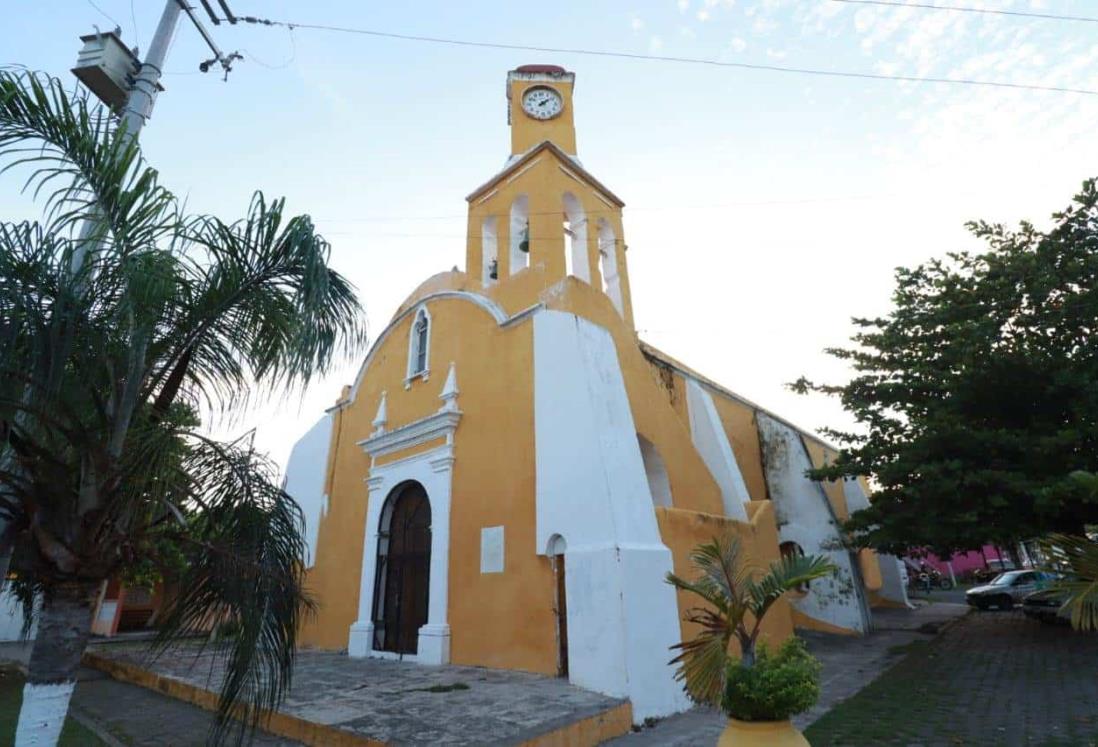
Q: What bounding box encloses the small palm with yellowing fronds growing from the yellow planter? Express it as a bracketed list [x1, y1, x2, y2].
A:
[666, 534, 836, 705]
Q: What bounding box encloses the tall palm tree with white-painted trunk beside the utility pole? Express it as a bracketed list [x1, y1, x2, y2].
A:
[0, 70, 366, 744]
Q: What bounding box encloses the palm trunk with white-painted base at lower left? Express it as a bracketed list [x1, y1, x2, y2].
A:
[15, 583, 96, 747]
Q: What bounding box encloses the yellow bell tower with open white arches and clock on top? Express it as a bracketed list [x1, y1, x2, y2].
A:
[466, 65, 632, 326]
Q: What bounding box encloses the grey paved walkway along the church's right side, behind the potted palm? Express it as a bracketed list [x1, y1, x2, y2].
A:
[607, 604, 967, 747]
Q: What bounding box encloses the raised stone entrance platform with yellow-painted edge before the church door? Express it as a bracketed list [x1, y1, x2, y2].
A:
[85, 644, 632, 747]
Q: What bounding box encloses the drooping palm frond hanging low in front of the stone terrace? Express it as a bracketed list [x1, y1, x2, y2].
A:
[155, 441, 313, 742]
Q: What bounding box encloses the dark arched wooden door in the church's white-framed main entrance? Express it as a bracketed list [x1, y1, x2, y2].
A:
[373, 482, 430, 654]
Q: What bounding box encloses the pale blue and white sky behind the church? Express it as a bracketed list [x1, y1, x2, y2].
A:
[0, 0, 1098, 472]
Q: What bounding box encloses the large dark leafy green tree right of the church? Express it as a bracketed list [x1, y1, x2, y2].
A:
[792, 179, 1098, 556]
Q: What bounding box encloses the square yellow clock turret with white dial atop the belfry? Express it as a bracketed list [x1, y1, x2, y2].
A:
[507, 65, 575, 156]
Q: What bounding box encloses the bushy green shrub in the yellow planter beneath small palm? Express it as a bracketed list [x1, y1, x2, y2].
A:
[721, 638, 820, 721]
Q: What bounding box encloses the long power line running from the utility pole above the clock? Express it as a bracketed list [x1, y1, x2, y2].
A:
[236, 14, 1098, 96]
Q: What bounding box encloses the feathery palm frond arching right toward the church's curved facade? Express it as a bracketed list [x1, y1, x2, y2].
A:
[148, 193, 367, 409]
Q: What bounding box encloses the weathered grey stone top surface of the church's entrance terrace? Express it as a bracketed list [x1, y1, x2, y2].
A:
[99, 645, 621, 745]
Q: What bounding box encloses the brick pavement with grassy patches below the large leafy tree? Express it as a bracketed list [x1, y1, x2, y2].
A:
[808, 610, 1098, 747]
